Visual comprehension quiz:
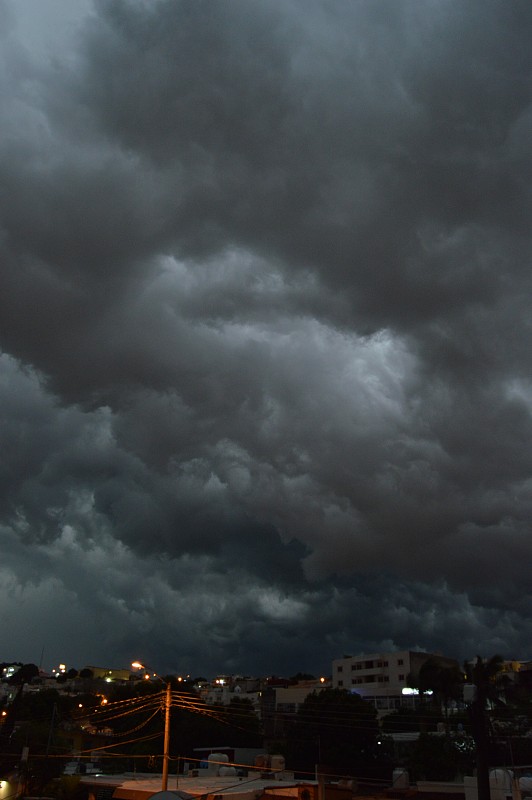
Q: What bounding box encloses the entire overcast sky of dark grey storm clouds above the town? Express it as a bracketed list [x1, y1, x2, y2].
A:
[0, 0, 532, 676]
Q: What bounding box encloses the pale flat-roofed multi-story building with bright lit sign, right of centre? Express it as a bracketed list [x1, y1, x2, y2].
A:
[332, 650, 457, 710]
